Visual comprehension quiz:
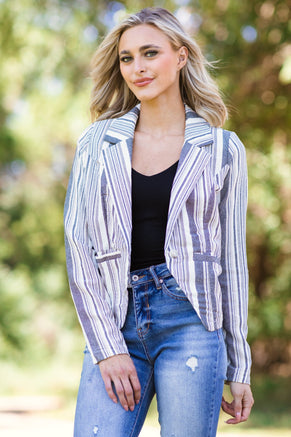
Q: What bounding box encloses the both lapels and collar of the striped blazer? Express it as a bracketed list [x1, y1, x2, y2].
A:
[102, 105, 213, 250]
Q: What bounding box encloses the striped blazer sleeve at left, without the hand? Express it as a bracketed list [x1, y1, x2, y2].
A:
[64, 125, 128, 363]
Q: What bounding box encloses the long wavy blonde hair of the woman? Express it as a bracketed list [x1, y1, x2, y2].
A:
[90, 8, 227, 126]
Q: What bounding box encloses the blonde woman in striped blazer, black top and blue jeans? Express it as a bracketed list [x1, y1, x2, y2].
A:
[65, 8, 253, 437]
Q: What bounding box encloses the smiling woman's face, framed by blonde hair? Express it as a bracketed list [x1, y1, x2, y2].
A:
[119, 24, 187, 102]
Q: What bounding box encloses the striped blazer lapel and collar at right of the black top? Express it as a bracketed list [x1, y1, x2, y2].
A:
[165, 106, 213, 247]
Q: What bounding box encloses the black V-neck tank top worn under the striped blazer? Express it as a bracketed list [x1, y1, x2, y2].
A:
[130, 162, 178, 271]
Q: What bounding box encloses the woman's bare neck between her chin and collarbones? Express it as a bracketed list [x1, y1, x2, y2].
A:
[136, 99, 185, 138]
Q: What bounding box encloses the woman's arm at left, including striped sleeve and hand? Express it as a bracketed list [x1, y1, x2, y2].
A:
[64, 125, 140, 410]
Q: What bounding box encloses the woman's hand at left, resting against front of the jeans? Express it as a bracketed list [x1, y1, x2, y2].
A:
[98, 354, 141, 411]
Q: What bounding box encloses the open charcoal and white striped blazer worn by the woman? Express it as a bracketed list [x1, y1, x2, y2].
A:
[64, 106, 251, 383]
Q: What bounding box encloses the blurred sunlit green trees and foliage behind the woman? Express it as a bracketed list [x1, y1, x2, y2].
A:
[0, 0, 291, 436]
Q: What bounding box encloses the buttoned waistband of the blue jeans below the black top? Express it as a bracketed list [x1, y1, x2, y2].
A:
[128, 263, 172, 289]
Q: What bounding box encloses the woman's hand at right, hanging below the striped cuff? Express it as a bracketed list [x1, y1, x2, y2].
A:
[221, 382, 254, 425]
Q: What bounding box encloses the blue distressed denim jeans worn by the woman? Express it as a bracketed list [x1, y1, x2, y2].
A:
[74, 264, 227, 437]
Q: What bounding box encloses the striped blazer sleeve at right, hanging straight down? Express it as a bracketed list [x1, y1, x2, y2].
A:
[219, 132, 251, 383]
